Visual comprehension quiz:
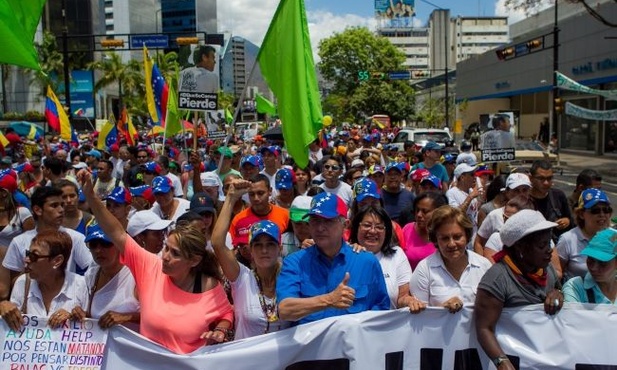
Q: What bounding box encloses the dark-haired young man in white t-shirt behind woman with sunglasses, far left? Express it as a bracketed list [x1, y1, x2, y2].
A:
[0, 186, 92, 298]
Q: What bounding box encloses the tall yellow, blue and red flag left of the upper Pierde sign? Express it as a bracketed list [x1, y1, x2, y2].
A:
[144, 44, 169, 126]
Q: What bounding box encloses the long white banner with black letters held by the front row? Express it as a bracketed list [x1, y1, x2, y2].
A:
[103, 304, 617, 370]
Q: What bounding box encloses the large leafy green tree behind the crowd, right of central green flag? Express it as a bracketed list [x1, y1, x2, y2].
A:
[318, 27, 414, 122]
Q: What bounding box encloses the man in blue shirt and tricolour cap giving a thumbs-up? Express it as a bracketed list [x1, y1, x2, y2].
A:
[276, 193, 390, 324]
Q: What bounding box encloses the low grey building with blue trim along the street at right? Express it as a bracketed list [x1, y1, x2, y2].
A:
[456, 0, 617, 154]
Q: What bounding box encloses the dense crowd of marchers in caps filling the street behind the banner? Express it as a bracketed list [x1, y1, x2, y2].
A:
[0, 126, 617, 369]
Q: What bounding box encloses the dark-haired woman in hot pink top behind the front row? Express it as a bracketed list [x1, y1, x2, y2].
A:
[403, 192, 448, 270]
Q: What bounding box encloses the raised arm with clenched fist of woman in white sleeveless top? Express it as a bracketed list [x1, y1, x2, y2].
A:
[212, 179, 251, 282]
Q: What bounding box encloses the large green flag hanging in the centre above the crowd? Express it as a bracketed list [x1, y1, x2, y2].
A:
[257, 0, 322, 167]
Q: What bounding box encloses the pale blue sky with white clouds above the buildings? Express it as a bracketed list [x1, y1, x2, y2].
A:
[217, 0, 548, 55]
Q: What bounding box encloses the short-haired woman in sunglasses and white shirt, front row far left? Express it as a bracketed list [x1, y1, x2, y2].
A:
[0, 230, 88, 331]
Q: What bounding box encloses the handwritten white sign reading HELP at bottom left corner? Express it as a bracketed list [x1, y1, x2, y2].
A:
[0, 315, 107, 370]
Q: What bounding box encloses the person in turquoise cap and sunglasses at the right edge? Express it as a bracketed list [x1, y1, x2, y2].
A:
[563, 229, 617, 305]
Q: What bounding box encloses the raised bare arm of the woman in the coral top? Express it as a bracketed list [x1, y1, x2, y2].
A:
[77, 170, 127, 253]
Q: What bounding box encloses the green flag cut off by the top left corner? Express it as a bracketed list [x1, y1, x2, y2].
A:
[0, 0, 45, 70]
